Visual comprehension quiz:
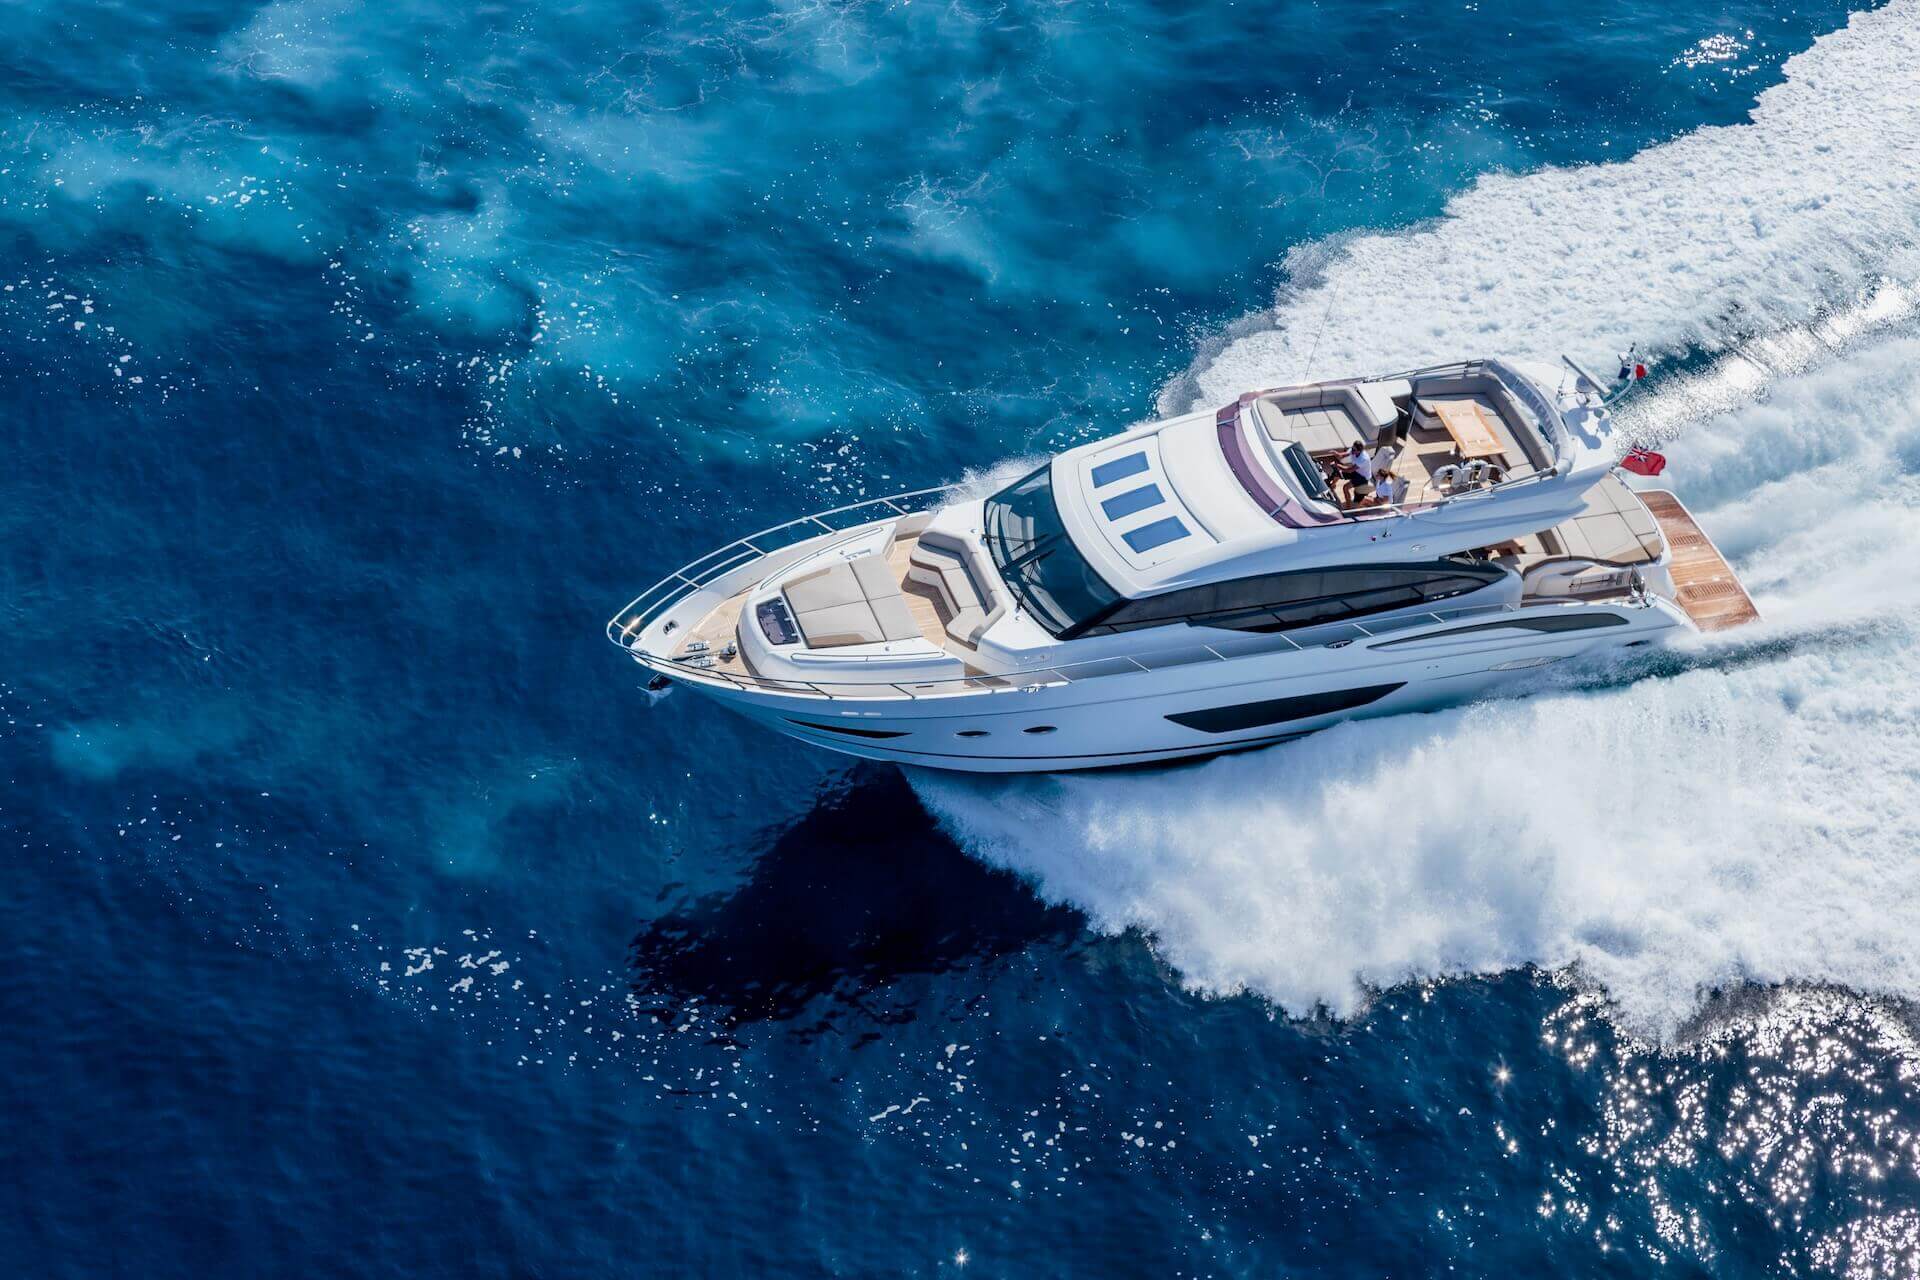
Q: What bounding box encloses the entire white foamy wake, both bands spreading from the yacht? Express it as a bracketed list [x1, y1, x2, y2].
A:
[914, 4, 1920, 1036]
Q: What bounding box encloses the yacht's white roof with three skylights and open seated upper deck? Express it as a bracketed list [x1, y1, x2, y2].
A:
[1052, 361, 1613, 597]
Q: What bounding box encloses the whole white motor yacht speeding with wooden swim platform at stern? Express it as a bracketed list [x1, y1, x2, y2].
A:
[609, 359, 1757, 771]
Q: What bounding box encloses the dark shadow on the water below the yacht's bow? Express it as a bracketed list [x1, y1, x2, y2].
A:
[628, 764, 1085, 1042]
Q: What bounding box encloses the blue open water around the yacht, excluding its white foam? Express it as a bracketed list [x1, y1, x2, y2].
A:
[0, 0, 1920, 1276]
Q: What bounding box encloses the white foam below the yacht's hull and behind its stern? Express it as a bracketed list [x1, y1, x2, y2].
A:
[916, 326, 1920, 1036]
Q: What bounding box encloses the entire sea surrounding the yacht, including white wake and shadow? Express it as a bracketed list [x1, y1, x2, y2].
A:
[11, 0, 1920, 1278]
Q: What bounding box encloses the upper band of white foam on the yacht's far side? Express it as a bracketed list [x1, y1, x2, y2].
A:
[1162, 0, 1920, 411]
